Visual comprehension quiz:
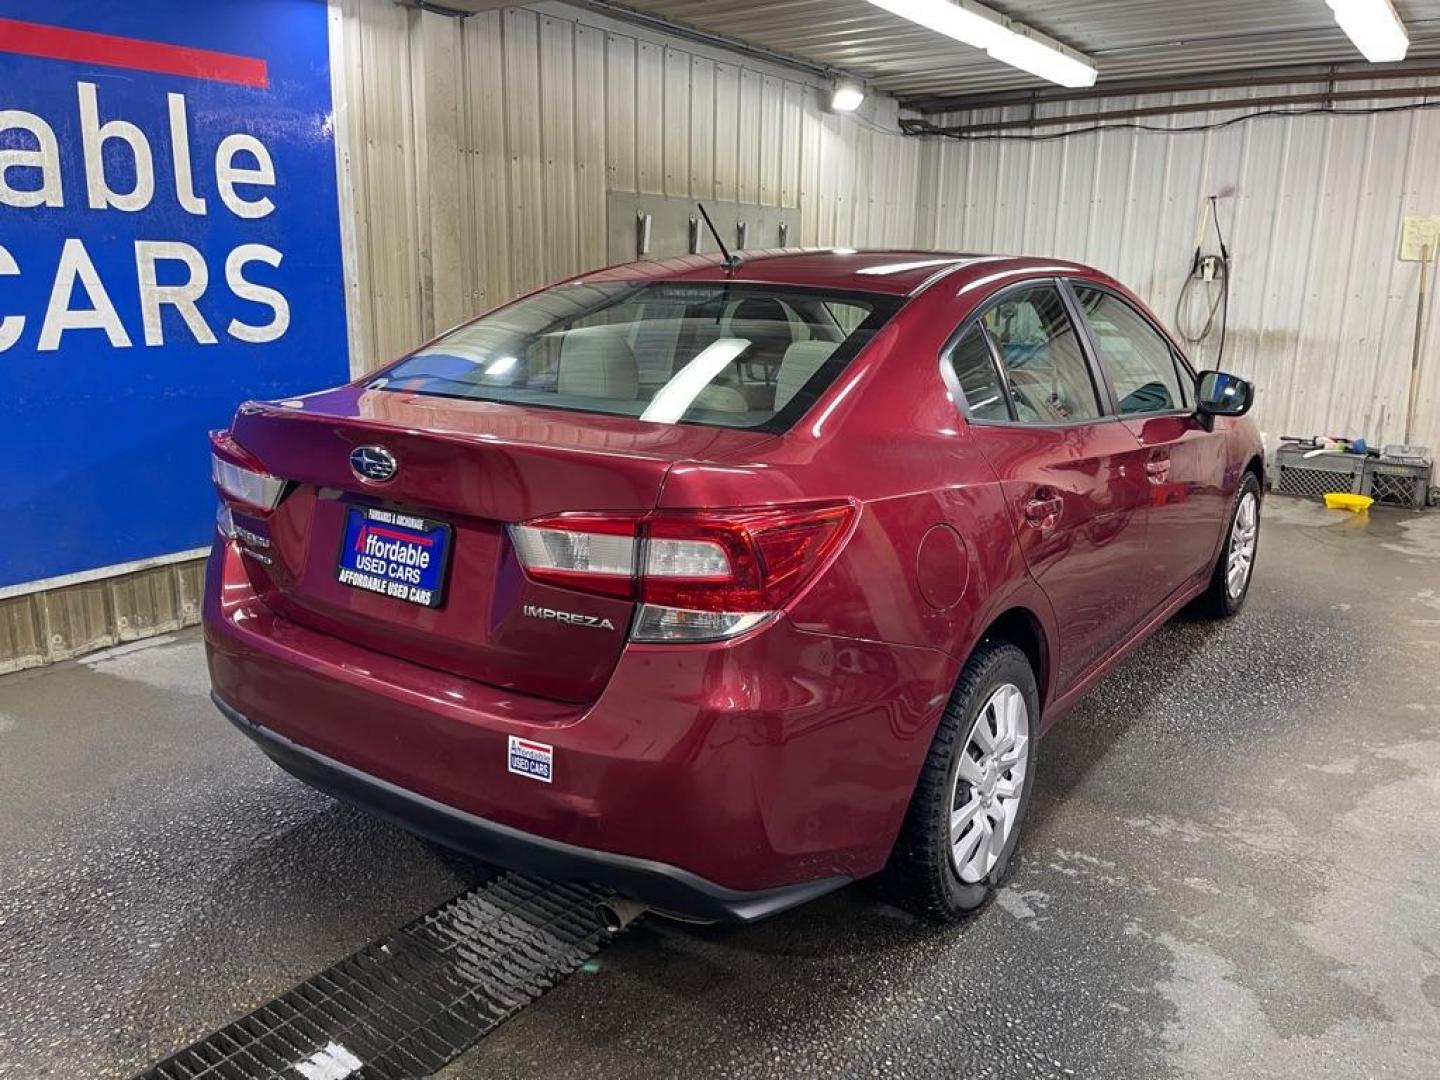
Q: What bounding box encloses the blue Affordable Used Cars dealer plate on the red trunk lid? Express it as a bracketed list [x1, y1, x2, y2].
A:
[336, 507, 451, 608]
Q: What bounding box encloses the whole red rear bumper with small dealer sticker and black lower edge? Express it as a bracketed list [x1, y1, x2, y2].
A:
[204, 543, 956, 919]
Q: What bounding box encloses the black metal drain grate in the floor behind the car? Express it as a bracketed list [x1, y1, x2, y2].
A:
[137, 874, 624, 1080]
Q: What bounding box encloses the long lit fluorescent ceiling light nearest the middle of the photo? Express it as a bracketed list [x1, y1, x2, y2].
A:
[870, 0, 1088, 86]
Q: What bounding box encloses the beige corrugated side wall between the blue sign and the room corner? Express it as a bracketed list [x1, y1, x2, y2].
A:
[334, 0, 922, 370]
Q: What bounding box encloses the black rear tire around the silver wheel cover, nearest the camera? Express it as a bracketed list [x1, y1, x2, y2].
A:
[884, 641, 1040, 923]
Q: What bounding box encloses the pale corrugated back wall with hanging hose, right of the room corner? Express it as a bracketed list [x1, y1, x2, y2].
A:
[923, 82, 1440, 446]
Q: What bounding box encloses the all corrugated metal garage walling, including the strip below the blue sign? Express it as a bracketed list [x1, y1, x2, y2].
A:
[0, 0, 1440, 672]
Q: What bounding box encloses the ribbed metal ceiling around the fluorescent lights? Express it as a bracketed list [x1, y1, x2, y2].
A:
[586, 0, 1440, 108]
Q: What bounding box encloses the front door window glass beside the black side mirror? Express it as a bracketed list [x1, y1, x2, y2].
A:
[1076, 285, 1189, 416]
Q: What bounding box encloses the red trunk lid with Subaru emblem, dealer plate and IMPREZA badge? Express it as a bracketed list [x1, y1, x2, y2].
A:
[221, 387, 769, 701]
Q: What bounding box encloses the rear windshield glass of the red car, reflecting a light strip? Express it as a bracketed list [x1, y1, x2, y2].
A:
[369, 282, 900, 432]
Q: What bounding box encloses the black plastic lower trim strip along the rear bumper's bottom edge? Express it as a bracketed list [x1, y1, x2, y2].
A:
[210, 693, 850, 923]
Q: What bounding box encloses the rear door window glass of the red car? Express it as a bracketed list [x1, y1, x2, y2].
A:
[981, 285, 1100, 423]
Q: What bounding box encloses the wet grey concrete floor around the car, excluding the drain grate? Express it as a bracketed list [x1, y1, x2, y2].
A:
[0, 498, 1440, 1080]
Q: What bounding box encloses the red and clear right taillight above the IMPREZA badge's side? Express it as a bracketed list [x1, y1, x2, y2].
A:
[510, 501, 857, 641]
